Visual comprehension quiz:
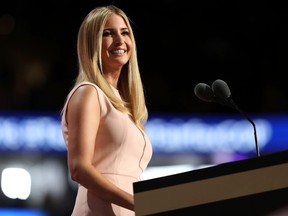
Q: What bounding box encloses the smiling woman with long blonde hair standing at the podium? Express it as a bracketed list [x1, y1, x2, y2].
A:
[62, 5, 152, 216]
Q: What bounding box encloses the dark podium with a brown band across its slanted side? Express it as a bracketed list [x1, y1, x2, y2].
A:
[133, 151, 288, 216]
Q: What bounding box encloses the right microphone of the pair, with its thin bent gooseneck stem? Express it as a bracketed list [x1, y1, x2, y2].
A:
[212, 79, 260, 157]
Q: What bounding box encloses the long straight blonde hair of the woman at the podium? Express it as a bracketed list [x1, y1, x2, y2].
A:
[69, 5, 148, 129]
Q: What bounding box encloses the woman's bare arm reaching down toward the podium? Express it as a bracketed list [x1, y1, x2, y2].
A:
[66, 86, 134, 210]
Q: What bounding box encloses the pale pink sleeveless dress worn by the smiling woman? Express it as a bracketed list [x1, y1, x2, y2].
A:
[61, 82, 152, 216]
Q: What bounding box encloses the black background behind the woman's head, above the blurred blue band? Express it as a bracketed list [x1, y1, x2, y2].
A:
[0, 0, 288, 113]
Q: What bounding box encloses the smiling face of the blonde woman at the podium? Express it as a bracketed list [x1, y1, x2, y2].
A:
[101, 14, 133, 73]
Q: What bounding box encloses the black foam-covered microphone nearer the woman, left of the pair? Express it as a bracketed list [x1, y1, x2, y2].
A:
[194, 83, 234, 108]
